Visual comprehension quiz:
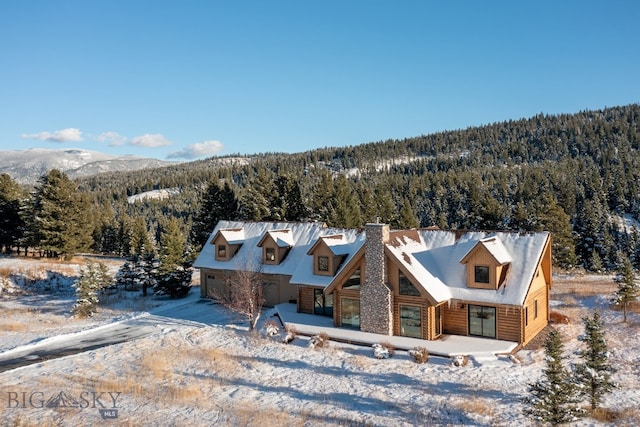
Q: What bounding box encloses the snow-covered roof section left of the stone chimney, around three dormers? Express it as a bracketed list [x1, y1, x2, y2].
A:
[193, 221, 364, 287]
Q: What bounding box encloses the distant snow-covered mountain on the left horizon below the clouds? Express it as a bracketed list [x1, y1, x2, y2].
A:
[0, 148, 175, 184]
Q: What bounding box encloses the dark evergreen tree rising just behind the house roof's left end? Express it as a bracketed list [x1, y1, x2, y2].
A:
[189, 179, 238, 249]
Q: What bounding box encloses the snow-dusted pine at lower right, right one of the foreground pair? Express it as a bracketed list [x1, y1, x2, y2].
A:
[576, 311, 616, 410]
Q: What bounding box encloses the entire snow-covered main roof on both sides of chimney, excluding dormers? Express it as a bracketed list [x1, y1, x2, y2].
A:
[194, 221, 549, 305]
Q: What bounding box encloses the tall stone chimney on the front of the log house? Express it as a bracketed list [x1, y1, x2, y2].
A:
[360, 222, 393, 335]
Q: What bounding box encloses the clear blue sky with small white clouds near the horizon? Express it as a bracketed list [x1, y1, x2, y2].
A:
[0, 0, 640, 160]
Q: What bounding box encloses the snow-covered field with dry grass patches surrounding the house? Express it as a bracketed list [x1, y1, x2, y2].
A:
[0, 258, 640, 426]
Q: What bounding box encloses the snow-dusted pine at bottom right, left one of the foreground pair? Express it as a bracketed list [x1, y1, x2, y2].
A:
[523, 330, 583, 425]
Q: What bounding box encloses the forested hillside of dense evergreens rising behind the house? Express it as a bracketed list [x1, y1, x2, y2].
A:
[0, 104, 640, 271]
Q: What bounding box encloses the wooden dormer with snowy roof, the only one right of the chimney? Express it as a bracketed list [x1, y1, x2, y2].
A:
[460, 236, 512, 290]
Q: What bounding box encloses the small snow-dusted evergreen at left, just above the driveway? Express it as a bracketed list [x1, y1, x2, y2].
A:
[73, 262, 113, 317]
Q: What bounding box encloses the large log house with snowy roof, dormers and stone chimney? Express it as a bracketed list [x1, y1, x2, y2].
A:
[194, 221, 551, 345]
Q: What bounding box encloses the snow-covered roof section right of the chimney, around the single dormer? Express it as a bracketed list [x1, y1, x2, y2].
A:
[387, 230, 548, 305]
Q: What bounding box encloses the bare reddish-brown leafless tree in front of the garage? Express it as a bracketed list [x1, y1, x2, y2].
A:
[215, 262, 264, 331]
